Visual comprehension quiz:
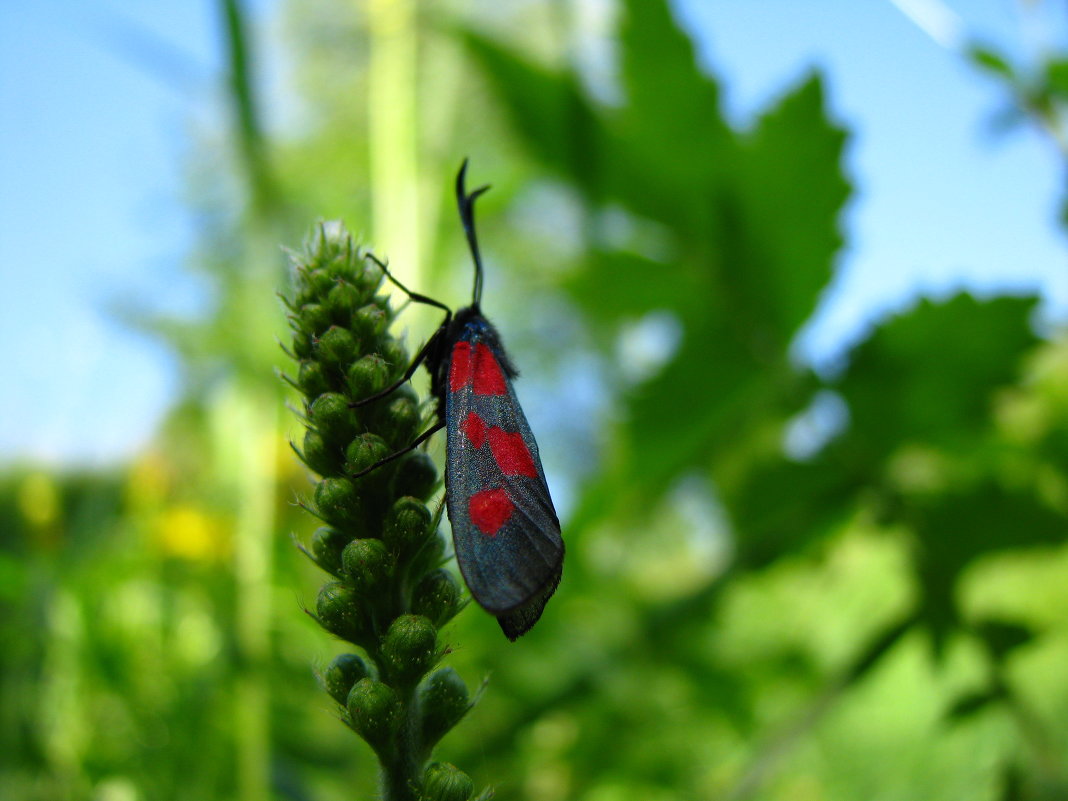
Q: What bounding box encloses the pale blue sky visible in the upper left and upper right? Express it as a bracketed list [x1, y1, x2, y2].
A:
[0, 0, 1068, 465]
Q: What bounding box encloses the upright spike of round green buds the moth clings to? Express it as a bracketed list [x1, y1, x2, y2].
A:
[283, 223, 491, 801]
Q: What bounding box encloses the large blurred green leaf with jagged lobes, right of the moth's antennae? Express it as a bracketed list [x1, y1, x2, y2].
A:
[469, 0, 848, 508]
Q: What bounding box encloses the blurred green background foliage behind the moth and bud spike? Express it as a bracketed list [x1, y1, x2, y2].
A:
[0, 0, 1068, 801]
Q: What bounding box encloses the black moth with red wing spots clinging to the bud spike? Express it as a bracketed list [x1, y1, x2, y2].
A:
[357, 160, 564, 641]
